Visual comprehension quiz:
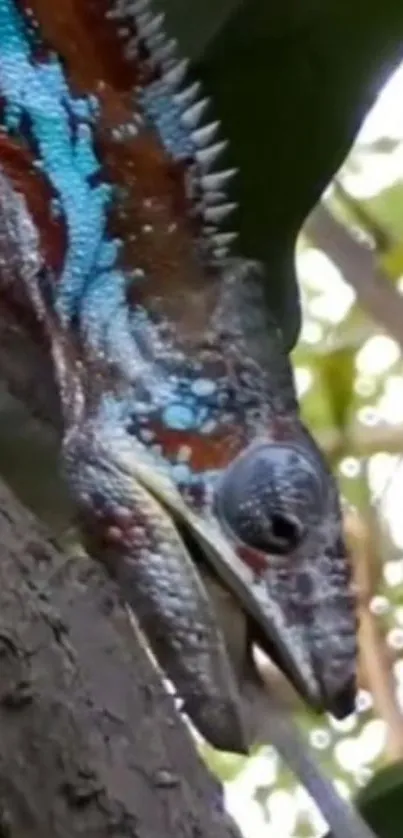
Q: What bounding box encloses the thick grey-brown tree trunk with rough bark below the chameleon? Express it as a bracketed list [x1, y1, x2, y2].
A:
[0, 483, 238, 838]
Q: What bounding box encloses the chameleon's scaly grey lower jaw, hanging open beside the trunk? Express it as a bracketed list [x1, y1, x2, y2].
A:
[63, 425, 249, 753]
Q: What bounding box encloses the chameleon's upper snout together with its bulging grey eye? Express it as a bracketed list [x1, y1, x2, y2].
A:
[215, 428, 357, 718]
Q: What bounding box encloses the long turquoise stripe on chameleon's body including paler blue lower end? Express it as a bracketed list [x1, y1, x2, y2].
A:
[0, 0, 156, 392]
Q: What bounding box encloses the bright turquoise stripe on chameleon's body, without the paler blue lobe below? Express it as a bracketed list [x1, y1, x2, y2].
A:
[0, 0, 111, 320]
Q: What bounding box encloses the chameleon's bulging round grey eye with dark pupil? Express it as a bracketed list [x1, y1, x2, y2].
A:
[215, 443, 325, 555]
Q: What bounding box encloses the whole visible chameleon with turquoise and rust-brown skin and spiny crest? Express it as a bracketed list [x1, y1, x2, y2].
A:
[0, 0, 356, 796]
